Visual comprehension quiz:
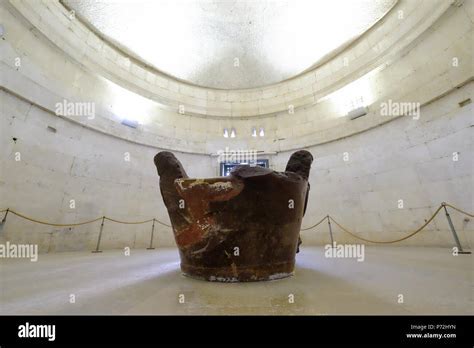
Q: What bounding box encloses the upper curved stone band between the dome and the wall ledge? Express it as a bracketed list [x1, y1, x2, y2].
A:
[2, 1, 473, 154]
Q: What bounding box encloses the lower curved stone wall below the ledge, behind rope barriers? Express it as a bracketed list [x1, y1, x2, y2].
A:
[0, 83, 474, 251]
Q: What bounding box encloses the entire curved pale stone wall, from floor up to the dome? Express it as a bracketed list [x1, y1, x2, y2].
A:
[0, 0, 474, 251]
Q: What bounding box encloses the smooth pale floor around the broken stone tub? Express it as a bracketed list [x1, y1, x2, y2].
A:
[0, 246, 474, 315]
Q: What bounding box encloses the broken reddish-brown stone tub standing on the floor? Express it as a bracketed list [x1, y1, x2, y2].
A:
[154, 150, 313, 282]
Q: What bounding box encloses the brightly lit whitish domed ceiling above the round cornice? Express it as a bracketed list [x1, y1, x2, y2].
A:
[62, 0, 397, 89]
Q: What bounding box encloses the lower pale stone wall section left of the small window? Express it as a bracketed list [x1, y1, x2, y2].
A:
[0, 91, 215, 252]
